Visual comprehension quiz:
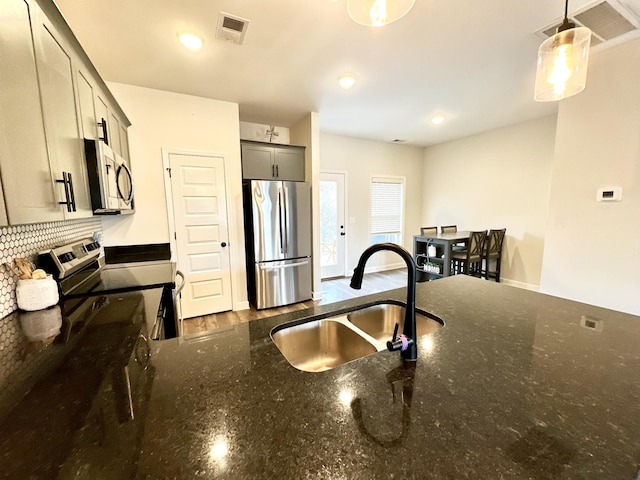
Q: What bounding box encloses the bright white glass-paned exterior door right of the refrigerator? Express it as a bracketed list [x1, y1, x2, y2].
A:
[320, 172, 347, 278]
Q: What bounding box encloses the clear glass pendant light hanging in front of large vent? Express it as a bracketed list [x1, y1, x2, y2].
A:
[534, 0, 591, 102]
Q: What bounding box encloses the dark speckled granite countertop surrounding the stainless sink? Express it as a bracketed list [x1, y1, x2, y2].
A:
[0, 276, 640, 480]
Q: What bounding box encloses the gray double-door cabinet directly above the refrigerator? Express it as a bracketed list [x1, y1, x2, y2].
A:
[241, 141, 304, 182]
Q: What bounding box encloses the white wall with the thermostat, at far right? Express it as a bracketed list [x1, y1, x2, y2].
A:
[541, 40, 640, 315]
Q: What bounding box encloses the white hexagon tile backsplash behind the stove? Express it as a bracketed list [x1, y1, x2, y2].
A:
[0, 218, 102, 318]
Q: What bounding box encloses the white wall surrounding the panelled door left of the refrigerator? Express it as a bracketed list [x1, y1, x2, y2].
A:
[103, 83, 248, 309]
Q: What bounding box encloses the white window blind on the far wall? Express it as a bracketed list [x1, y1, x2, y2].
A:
[371, 178, 403, 234]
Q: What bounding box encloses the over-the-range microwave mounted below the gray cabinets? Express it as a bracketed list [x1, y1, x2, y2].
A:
[84, 138, 134, 215]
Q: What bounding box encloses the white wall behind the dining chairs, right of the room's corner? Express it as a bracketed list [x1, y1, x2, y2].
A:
[422, 116, 556, 289]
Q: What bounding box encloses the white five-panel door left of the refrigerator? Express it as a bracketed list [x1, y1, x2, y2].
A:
[168, 152, 232, 318]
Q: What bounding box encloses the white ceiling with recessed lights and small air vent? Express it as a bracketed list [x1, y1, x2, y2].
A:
[56, 0, 640, 146]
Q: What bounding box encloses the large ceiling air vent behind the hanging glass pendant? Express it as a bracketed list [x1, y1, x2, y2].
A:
[538, 0, 640, 49]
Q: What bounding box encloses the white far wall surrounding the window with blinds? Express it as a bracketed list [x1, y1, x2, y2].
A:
[317, 133, 423, 272]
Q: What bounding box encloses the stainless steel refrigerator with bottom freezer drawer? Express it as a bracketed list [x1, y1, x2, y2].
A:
[243, 180, 311, 309]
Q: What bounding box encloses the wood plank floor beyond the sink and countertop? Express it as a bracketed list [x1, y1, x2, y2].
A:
[182, 268, 407, 335]
